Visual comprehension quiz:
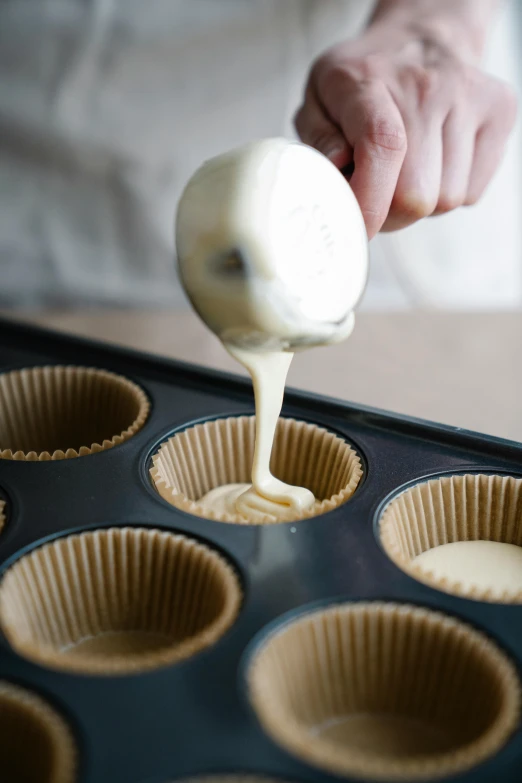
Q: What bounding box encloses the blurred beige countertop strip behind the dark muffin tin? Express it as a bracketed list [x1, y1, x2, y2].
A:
[8, 310, 522, 448]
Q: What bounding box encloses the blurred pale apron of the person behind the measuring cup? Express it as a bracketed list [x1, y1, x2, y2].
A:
[0, 0, 521, 307]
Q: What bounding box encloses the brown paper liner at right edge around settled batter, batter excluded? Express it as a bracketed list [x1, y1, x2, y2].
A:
[380, 474, 522, 603]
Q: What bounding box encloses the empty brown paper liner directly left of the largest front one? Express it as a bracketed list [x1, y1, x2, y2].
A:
[0, 528, 242, 674]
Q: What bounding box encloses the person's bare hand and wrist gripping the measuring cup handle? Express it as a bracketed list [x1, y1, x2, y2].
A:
[295, 0, 516, 238]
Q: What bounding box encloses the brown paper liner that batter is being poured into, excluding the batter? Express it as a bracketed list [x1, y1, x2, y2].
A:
[150, 416, 362, 524]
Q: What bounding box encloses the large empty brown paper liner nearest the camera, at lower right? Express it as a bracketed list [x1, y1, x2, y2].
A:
[248, 602, 520, 781]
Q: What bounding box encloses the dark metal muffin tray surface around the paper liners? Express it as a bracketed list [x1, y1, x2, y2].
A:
[0, 320, 522, 783]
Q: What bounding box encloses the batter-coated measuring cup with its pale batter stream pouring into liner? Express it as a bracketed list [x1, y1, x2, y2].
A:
[176, 139, 368, 520]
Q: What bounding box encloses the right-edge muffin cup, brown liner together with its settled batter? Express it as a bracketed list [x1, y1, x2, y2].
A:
[379, 474, 522, 603]
